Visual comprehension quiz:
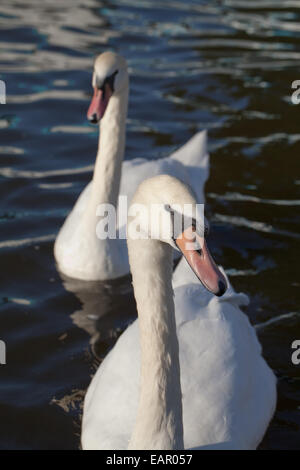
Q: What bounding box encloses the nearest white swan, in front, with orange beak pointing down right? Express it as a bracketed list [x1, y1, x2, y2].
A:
[82, 175, 276, 450]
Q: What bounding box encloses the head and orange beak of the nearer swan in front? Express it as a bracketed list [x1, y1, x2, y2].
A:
[127, 175, 227, 297]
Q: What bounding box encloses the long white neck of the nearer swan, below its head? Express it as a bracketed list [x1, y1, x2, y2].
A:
[128, 240, 184, 450]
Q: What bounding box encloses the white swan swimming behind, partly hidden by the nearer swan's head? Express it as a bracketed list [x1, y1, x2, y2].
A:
[54, 52, 209, 281]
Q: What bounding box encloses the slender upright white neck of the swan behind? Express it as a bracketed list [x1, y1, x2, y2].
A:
[88, 84, 128, 222]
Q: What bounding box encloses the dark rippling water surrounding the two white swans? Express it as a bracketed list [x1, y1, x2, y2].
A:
[0, 0, 300, 449]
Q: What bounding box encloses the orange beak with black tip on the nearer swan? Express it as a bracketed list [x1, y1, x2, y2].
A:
[176, 226, 227, 297]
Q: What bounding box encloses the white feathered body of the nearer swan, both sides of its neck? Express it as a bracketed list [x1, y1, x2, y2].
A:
[82, 276, 276, 450]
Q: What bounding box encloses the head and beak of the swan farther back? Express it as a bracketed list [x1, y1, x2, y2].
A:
[87, 51, 128, 124]
